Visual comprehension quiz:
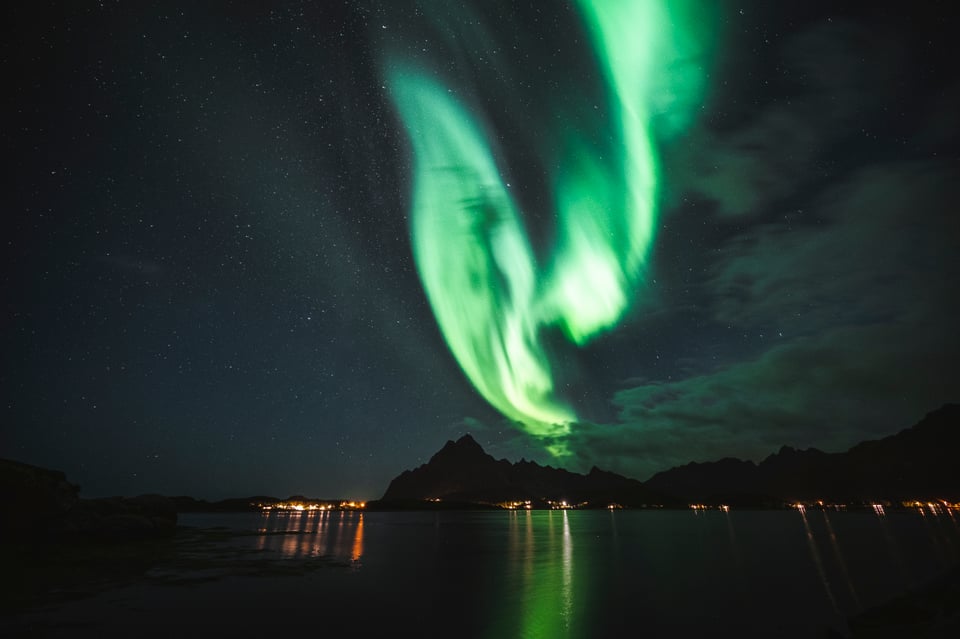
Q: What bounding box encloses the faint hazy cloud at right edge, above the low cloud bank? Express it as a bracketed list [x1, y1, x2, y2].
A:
[708, 163, 960, 334]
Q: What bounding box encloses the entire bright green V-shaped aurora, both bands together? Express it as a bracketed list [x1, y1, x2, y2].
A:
[387, 0, 702, 455]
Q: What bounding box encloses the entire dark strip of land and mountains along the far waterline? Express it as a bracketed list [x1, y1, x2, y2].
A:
[0, 404, 960, 524]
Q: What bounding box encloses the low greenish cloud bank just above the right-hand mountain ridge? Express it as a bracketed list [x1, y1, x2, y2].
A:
[569, 324, 960, 479]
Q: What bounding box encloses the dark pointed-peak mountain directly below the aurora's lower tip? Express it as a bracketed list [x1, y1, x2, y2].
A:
[367, 435, 676, 509]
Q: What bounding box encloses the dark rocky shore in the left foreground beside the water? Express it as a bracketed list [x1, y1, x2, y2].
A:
[0, 459, 177, 616]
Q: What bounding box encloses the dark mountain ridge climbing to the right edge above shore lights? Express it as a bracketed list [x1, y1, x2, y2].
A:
[645, 404, 960, 506]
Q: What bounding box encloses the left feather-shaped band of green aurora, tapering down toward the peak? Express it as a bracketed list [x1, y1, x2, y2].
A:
[391, 68, 575, 444]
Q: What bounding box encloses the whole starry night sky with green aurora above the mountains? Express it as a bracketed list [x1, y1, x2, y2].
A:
[0, 0, 960, 498]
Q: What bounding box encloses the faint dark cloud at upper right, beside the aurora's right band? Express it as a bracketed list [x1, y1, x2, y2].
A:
[672, 16, 910, 219]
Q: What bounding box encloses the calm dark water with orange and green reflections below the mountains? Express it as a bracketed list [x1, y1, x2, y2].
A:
[9, 510, 960, 637]
